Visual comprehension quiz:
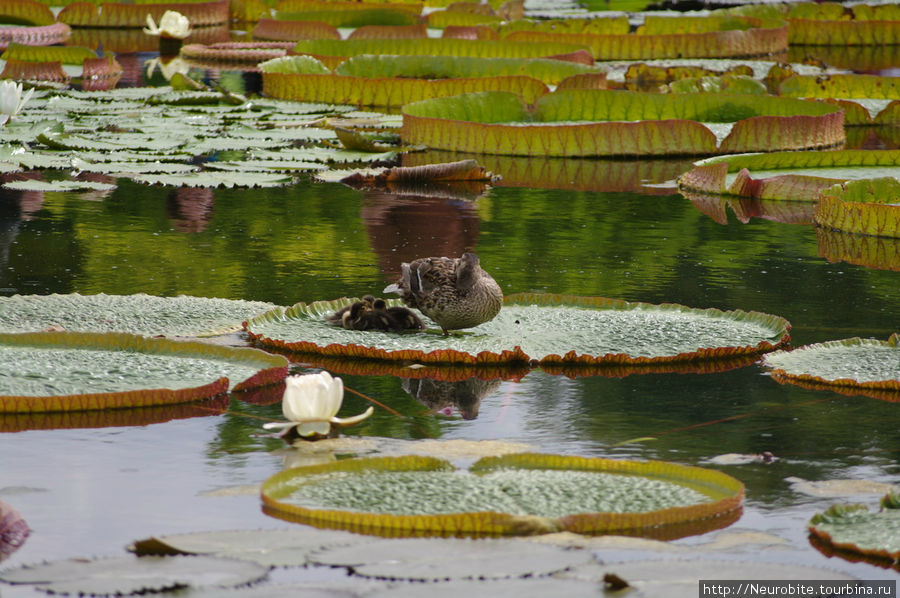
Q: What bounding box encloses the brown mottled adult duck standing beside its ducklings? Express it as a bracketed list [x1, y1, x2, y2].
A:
[383, 252, 503, 336]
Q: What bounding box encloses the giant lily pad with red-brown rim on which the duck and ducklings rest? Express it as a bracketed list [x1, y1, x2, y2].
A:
[245, 294, 790, 367]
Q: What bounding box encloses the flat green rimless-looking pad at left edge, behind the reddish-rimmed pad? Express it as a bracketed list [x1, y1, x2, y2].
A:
[0, 293, 274, 336]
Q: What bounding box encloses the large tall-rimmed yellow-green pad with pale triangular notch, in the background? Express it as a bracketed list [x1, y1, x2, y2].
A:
[403, 90, 844, 156]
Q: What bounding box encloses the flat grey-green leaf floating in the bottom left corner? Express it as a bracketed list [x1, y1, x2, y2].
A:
[0, 556, 269, 596]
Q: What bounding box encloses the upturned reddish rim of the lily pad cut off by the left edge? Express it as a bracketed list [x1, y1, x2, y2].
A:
[0, 332, 288, 413]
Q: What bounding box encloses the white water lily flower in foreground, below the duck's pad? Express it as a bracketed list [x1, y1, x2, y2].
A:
[263, 372, 374, 436]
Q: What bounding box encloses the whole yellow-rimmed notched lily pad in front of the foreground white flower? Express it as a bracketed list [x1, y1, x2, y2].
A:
[262, 453, 744, 536]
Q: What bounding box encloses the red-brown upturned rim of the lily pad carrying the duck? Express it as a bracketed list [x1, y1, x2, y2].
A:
[244, 293, 791, 368]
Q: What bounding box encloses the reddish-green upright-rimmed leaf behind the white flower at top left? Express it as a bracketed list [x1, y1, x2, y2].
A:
[56, 0, 231, 30]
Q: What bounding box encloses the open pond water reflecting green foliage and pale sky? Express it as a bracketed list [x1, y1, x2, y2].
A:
[0, 42, 900, 596]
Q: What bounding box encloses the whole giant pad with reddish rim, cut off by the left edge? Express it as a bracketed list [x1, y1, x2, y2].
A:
[0, 332, 288, 413]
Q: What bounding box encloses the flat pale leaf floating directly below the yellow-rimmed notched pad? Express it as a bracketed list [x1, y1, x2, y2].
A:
[312, 538, 591, 580]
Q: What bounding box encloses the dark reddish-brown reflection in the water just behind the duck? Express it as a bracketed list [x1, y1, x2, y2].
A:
[361, 191, 479, 277]
